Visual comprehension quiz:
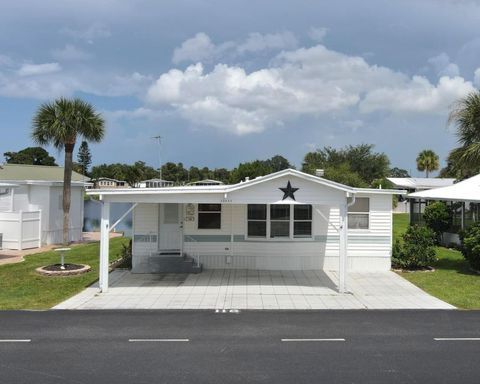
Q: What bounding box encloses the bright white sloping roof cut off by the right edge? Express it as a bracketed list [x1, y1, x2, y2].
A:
[407, 175, 480, 202]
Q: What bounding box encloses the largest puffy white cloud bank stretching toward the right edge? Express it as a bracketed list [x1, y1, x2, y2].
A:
[146, 45, 473, 135]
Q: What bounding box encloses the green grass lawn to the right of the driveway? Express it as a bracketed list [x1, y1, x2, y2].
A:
[393, 213, 480, 309]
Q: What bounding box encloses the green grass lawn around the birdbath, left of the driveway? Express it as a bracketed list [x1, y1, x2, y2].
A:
[0, 238, 129, 309]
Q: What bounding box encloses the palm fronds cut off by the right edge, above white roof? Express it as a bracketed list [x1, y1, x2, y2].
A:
[448, 91, 480, 173]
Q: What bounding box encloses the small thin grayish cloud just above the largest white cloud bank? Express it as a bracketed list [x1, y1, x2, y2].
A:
[172, 31, 298, 64]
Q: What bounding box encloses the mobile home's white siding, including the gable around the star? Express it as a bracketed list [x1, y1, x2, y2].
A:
[129, 176, 392, 272]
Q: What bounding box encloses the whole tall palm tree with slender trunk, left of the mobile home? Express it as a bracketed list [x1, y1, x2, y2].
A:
[32, 98, 105, 244]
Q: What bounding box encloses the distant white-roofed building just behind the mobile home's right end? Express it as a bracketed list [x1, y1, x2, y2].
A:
[387, 177, 455, 213]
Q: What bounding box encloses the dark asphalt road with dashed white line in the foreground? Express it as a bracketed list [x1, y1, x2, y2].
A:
[0, 310, 480, 384]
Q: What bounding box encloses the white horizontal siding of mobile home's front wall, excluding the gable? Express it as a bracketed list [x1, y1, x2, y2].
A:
[133, 195, 392, 272]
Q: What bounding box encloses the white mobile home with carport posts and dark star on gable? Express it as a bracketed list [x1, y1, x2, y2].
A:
[89, 169, 398, 290]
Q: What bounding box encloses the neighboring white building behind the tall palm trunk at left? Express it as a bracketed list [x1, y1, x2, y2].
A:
[0, 164, 86, 250]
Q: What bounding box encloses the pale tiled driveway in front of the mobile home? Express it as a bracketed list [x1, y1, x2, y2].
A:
[55, 270, 454, 309]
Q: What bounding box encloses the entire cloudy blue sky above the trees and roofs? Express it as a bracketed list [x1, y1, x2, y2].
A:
[0, 0, 480, 175]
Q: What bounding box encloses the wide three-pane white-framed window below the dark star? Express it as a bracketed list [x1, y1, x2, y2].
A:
[247, 204, 312, 239]
